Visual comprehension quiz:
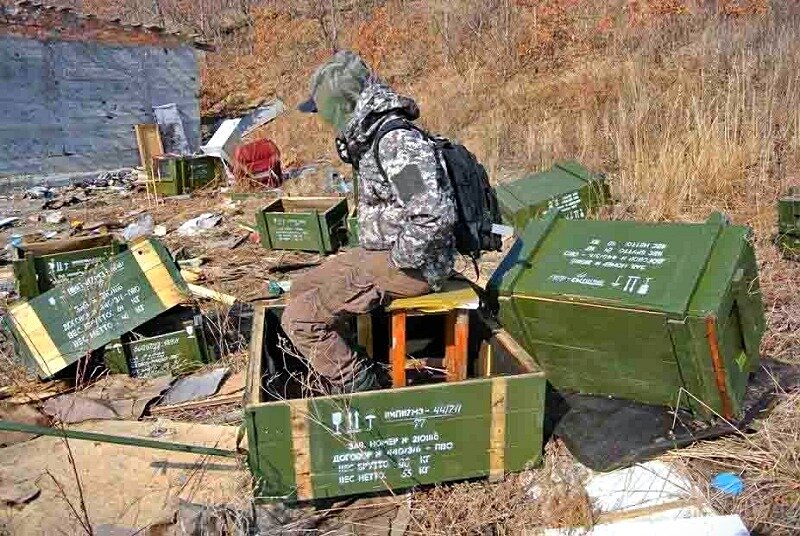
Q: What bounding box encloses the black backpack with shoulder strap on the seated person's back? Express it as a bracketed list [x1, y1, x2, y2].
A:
[372, 118, 502, 261]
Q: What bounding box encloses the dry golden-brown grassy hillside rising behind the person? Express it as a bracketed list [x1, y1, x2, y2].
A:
[202, 0, 800, 361]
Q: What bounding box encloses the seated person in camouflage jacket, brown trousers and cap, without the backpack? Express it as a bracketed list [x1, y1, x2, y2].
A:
[282, 51, 456, 393]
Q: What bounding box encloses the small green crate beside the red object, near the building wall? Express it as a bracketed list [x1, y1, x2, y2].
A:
[154, 155, 218, 196]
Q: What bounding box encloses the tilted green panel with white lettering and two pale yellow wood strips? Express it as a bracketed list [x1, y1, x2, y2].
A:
[7, 239, 188, 378]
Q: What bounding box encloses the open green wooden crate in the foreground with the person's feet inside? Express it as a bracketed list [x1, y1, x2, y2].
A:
[245, 307, 546, 500]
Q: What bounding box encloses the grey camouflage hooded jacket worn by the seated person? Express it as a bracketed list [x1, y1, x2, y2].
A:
[343, 81, 456, 290]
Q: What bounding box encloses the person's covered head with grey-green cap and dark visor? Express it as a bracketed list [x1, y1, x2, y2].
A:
[297, 50, 371, 132]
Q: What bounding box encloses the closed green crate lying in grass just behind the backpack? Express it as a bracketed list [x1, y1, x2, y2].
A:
[495, 162, 611, 230]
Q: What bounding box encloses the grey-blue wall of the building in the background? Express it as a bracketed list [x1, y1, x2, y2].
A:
[0, 36, 200, 176]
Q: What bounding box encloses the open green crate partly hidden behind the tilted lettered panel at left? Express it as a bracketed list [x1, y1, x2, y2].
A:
[12, 235, 127, 299]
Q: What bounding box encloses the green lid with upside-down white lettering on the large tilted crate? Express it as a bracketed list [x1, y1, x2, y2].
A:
[489, 211, 727, 315]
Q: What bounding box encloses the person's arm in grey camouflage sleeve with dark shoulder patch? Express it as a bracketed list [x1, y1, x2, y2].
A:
[378, 129, 455, 268]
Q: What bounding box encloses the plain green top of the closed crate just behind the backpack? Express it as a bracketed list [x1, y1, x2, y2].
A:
[496, 161, 603, 204]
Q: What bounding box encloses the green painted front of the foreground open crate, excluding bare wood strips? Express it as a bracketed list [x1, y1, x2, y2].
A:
[245, 373, 545, 498]
